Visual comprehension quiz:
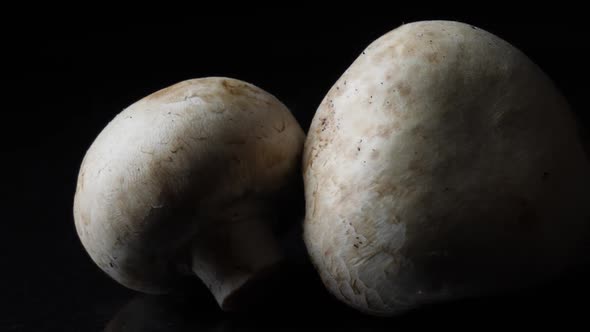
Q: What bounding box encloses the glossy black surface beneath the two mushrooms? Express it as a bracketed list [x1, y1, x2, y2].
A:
[6, 250, 590, 332]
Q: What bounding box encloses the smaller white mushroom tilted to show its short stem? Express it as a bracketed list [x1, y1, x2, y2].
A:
[74, 77, 305, 310]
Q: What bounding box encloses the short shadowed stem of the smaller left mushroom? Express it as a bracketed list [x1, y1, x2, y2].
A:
[192, 218, 283, 311]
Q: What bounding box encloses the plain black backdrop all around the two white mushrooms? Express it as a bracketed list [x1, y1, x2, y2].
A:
[5, 13, 590, 331]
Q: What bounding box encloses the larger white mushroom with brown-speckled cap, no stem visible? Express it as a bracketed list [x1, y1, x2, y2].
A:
[303, 21, 590, 316]
